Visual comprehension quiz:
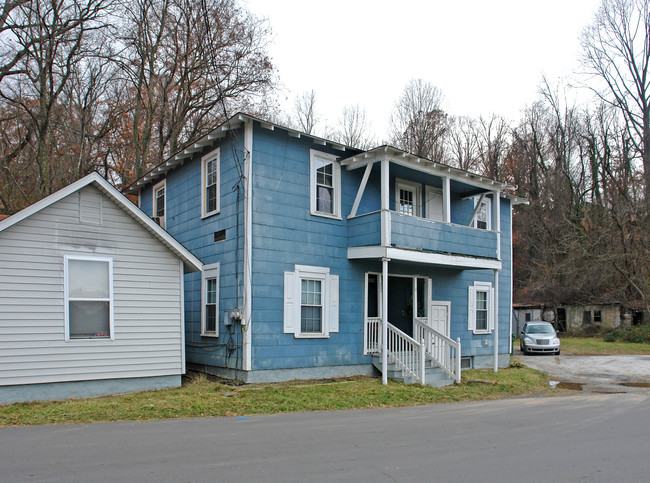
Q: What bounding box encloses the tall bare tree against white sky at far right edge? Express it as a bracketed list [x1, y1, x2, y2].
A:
[582, 0, 650, 200]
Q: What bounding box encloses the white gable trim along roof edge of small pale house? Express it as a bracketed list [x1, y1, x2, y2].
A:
[0, 173, 203, 272]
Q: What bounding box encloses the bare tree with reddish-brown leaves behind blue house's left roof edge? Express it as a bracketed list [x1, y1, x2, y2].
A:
[120, 0, 273, 181]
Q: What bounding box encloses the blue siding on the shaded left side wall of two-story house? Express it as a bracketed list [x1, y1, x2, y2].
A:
[141, 130, 244, 368]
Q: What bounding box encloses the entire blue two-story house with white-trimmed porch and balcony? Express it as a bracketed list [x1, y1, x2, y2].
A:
[127, 114, 522, 382]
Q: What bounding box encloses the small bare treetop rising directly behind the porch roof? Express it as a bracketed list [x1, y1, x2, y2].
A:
[390, 79, 449, 161]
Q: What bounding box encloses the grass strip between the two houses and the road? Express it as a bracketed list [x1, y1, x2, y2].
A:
[0, 363, 559, 426]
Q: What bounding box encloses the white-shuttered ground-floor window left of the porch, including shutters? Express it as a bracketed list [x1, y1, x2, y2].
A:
[284, 265, 339, 338]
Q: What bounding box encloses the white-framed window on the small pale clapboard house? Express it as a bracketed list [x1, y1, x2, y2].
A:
[64, 256, 113, 340]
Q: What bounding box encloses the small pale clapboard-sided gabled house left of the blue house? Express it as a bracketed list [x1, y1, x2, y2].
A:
[0, 173, 202, 404]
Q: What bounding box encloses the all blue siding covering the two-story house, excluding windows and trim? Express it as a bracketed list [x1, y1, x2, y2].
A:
[141, 119, 511, 376]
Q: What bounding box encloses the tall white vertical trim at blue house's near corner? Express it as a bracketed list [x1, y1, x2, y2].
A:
[241, 121, 253, 371]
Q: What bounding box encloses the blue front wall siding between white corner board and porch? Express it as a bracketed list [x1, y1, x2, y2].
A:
[252, 127, 369, 370]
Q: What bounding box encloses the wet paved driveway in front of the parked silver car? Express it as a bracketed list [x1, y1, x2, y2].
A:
[515, 348, 650, 392]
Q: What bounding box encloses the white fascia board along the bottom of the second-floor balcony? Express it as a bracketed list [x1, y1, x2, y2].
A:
[348, 246, 502, 270]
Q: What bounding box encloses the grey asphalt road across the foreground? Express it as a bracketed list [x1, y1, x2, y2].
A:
[0, 394, 650, 483]
